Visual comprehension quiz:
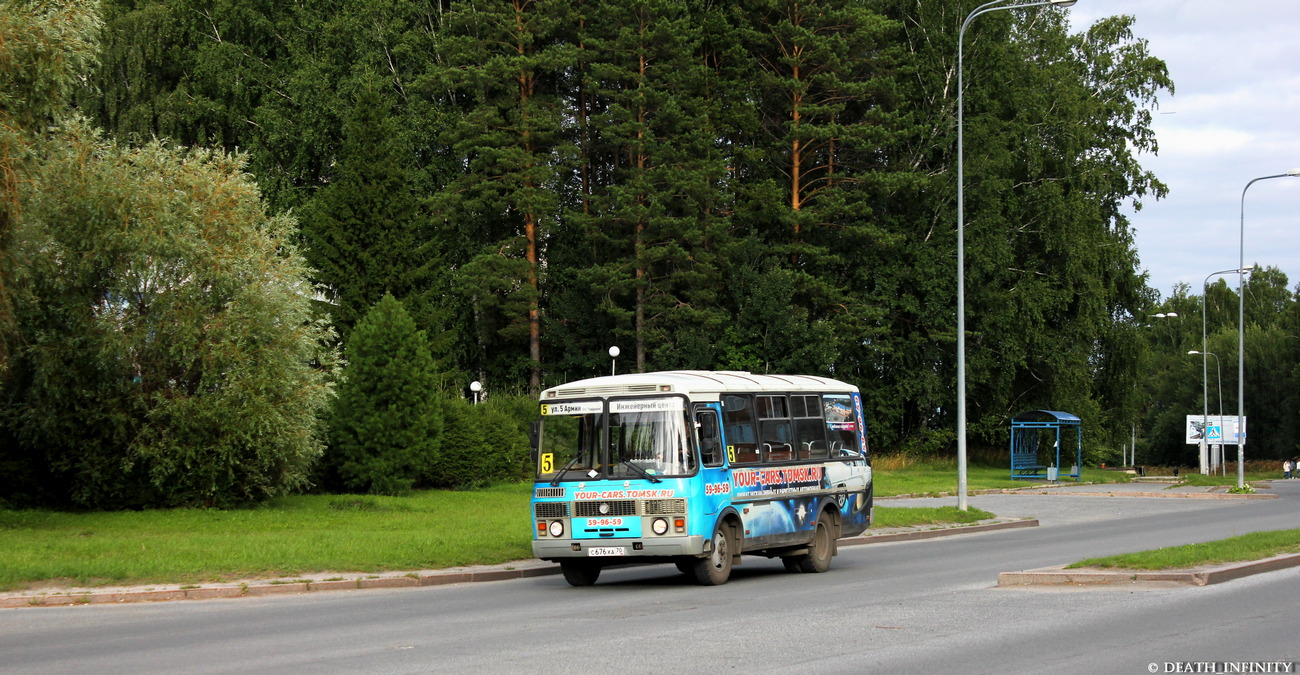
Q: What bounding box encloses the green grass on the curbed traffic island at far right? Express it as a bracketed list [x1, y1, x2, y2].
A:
[1067, 529, 1300, 570]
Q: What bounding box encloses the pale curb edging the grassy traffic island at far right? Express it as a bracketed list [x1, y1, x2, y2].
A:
[997, 553, 1300, 587]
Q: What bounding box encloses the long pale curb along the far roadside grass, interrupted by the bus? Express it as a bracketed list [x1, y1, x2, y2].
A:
[0, 520, 1039, 609]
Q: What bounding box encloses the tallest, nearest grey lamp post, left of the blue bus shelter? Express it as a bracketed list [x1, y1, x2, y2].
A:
[957, 0, 1078, 511]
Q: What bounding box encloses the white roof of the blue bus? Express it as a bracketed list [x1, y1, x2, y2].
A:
[542, 371, 858, 401]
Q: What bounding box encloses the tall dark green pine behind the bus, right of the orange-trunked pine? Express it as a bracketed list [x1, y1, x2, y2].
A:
[553, 0, 725, 371]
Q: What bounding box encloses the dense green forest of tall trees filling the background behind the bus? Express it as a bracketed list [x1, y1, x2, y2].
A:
[0, 0, 1300, 506]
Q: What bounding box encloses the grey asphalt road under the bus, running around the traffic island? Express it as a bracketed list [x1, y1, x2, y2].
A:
[0, 481, 1300, 674]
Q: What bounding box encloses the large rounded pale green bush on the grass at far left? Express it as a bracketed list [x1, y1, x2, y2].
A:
[0, 121, 335, 509]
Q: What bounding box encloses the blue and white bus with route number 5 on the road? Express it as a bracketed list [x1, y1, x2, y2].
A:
[532, 371, 872, 587]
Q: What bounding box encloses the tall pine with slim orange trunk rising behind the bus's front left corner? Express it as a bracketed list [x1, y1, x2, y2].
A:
[425, 0, 575, 391]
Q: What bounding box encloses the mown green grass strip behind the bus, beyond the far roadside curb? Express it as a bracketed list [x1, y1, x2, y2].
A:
[0, 483, 992, 590]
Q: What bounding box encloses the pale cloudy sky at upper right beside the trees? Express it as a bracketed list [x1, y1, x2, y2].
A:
[1069, 0, 1300, 298]
